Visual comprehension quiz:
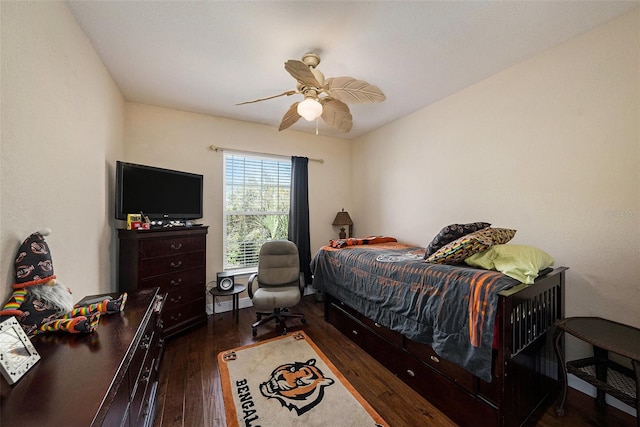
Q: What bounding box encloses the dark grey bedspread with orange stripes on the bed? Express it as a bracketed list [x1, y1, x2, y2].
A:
[311, 242, 519, 382]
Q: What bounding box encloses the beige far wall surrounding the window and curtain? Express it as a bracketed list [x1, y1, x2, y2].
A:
[124, 103, 351, 296]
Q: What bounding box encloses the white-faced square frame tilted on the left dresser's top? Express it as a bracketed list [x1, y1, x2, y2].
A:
[0, 317, 40, 385]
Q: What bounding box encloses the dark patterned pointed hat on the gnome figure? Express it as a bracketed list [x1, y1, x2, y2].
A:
[13, 230, 56, 289]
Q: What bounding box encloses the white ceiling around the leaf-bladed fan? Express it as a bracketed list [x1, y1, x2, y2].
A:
[68, 0, 640, 138]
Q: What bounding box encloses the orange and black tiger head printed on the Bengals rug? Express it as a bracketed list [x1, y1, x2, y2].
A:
[260, 359, 334, 415]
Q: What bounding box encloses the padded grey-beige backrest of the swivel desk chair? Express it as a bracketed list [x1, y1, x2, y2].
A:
[258, 240, 300, 286]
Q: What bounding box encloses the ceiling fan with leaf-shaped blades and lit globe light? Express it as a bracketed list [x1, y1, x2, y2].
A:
[236, 53, 386, 133]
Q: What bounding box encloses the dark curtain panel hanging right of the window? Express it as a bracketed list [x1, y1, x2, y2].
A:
[289, 156, 311, 284]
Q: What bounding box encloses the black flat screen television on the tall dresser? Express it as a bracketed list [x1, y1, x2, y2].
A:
[115, 161, 203, 220]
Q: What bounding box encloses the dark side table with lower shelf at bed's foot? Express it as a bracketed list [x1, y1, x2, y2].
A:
[555, 317, 640, 427]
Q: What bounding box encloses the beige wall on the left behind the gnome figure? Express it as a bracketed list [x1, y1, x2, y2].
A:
[0, 1, 124, 303]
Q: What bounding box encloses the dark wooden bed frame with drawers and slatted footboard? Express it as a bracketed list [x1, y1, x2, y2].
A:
[325, 268, 566, 426]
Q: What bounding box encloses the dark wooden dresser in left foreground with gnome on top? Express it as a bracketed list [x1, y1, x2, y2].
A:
[0, 288, 163, 427]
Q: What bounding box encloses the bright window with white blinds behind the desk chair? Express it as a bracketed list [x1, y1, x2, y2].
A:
[224, 152, 291, 270]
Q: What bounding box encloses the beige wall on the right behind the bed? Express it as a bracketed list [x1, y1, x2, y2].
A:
[352, 10, 640, 364]
